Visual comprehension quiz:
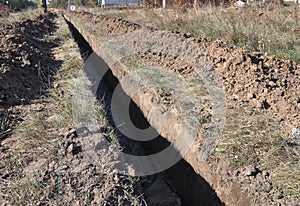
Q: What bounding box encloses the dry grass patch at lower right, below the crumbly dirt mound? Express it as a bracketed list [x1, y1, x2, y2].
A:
[215, 104, 300, 198]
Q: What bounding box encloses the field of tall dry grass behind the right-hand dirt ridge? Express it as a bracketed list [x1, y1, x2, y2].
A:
[98, 4, 300, 63]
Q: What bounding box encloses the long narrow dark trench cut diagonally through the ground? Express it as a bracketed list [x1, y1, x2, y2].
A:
[64, 17, 224, 206]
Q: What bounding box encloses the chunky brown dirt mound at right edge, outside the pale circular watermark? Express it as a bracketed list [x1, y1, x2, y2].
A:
[195, 40, 300, 128]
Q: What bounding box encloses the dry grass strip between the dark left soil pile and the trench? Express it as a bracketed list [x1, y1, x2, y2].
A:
[0, 14, 142, 205]
